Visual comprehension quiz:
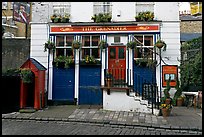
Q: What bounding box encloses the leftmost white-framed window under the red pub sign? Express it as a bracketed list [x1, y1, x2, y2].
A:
[56, 35, 74, 56]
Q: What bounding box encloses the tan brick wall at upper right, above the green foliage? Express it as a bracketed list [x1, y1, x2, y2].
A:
[180, 21, 202, 33]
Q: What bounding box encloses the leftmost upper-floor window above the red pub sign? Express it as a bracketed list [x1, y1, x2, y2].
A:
[53, 2, 71, 16]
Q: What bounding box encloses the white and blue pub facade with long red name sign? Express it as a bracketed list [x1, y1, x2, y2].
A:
[31, 2, 180, 114]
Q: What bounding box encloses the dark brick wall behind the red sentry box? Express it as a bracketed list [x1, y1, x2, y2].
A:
[2, 39, 30, 72]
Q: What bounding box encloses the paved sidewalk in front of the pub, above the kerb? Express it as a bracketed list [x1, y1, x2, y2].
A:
[2, 105, 202, 132]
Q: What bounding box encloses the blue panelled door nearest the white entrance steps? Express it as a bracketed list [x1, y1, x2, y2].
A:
[79, 65, 103, 105]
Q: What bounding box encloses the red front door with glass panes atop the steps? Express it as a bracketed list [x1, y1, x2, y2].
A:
[108, 46, 126, 81]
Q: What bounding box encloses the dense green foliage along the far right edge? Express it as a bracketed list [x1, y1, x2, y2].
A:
[180, 37, 202, 89]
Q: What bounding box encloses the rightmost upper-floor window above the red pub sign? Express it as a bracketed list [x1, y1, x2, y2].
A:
[135, 2, 154, 15]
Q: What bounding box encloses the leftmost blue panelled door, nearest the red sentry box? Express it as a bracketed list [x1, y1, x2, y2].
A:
[52, 67, 75, 102]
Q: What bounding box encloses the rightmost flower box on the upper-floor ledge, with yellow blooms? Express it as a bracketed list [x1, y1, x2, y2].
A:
[135, 11, 154, 21]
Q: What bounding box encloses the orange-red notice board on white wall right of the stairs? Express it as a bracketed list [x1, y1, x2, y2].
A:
[162, 65, 178, 87]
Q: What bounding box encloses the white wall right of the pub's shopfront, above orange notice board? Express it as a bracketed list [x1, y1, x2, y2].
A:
[154, 2, 180, 97]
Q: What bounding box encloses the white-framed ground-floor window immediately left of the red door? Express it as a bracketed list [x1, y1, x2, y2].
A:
[81, 35, 100, 59]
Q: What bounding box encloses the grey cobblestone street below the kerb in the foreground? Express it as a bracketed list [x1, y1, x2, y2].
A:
[2, 119, 202, 135]
